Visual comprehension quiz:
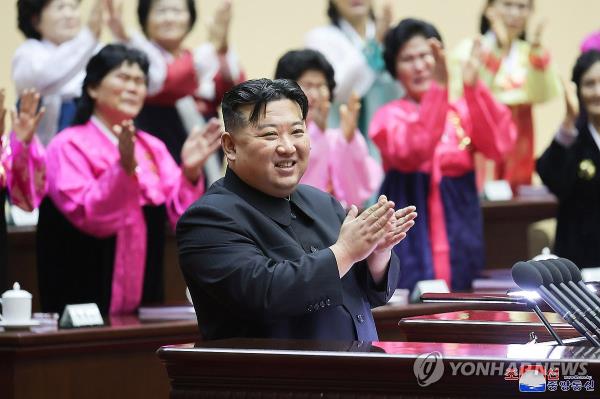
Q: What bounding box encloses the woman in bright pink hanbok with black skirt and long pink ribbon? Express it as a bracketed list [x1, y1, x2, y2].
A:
[37, 45, 222, 314]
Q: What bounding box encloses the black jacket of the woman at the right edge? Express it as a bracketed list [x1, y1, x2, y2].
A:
[537, 118, 600, 267]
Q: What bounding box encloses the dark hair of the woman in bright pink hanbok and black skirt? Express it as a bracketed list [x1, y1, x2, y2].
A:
[72, 44, 149, 125]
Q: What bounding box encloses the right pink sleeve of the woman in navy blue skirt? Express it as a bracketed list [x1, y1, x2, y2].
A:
[464, 81, 517, 161]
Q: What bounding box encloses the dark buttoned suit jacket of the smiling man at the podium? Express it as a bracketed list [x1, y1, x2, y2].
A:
[177, 169, 399, 341]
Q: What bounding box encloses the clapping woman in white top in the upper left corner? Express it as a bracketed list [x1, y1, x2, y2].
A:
[12, 0, 103, 145]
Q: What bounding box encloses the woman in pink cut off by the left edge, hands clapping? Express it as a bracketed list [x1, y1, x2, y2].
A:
[0, 89, 45, 289]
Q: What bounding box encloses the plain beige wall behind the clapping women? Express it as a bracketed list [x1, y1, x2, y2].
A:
[0, 0, 600, 158]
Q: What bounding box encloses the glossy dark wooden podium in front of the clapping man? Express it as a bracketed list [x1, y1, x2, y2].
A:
[158, 340, 600, 399]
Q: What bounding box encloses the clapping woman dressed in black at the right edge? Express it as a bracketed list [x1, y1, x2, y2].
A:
[537, 50, 600, 267]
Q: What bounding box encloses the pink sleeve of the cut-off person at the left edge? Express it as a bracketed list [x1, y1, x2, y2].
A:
[7, 132, 46, 211]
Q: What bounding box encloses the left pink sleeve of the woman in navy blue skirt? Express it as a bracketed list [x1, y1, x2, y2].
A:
[369, 83, 448, 172]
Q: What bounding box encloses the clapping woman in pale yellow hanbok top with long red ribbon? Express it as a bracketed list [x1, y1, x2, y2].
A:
[451, 0, 560, 194]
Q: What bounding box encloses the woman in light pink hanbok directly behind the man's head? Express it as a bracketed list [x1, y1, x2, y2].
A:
[275, 50, 383, 207]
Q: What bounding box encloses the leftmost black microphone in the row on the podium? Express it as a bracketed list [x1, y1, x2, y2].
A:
[511, 262, 600, 346]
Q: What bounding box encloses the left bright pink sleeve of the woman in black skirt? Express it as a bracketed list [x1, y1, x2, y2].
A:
[47, 141, 140, 237]
